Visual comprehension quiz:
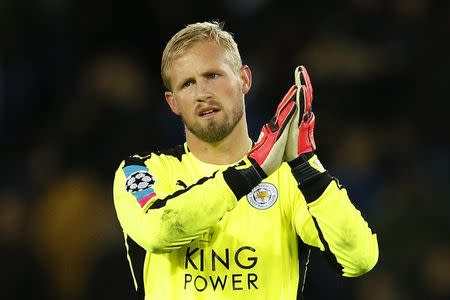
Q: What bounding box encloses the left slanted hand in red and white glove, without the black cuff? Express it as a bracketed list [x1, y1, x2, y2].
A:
[247, 85, 298, 177]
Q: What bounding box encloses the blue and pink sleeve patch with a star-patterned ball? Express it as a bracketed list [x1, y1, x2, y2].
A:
[123, 165, 156, 207]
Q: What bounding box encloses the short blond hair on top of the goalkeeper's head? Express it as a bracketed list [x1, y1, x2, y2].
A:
[161, 21, 242, 90]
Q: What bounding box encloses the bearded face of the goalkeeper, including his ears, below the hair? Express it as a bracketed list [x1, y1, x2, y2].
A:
[165, 41, 250, 143]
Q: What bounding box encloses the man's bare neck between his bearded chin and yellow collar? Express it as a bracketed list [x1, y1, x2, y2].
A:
[186, 118, 252, 165]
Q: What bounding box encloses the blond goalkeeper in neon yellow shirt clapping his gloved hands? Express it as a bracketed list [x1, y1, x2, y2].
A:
[114, 22, 378, 299]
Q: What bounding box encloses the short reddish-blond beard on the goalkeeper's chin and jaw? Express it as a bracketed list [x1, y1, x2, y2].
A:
[181, 104, 244, 143]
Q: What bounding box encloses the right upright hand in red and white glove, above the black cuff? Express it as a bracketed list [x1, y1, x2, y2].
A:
[284, 66, 316, 162]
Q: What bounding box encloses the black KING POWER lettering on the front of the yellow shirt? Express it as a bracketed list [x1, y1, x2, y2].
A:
[184, 246, 258, 292]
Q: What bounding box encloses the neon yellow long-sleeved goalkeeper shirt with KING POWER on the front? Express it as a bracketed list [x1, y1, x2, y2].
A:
[114, 143, 378, 300]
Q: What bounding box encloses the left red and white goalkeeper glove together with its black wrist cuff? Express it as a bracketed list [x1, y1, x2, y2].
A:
[223, 86, 297, 199]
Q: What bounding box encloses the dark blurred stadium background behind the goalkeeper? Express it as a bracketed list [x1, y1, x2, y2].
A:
[0, 0, 450, 300]
